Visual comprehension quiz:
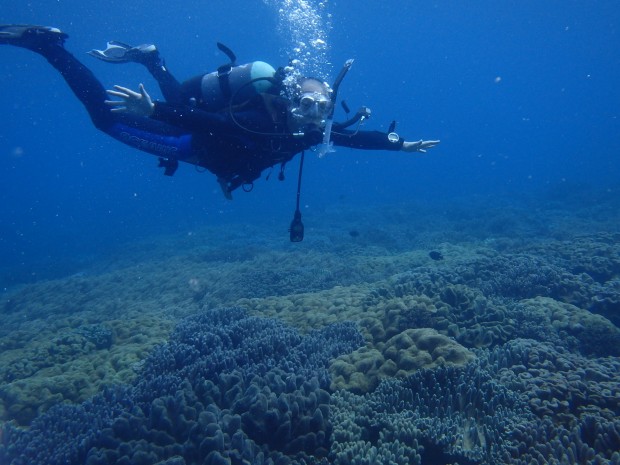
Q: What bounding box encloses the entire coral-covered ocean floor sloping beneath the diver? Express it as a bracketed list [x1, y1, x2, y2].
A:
[0, 187, 620, 465]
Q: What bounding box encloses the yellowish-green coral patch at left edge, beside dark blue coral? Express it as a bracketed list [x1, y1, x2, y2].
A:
[0, 311, 172, 425]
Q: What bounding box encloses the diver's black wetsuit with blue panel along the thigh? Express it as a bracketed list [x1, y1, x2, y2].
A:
[17, 38, 403, 191]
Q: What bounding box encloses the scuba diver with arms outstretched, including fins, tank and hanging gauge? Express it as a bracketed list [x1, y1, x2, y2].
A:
[0, 25, 439, 242]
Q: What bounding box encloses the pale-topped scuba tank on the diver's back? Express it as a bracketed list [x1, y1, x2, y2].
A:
[199, 61, 276, 111]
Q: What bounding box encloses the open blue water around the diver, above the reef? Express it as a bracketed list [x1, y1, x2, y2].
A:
[0, 0, 620, 287]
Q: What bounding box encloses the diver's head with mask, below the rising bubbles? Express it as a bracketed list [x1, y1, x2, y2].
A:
[290, 78, 334, 127]
